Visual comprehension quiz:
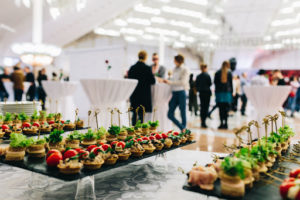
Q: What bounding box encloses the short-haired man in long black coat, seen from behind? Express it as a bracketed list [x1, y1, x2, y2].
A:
[128, 51, 156, 126]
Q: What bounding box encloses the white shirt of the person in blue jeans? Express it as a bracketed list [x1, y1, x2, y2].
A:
[170, 65, 189, 91]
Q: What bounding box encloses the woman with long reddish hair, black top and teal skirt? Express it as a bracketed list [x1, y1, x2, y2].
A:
[214, 61, 232, 129]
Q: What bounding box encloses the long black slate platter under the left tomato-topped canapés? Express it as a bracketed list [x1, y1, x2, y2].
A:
[0, 141, 195, 181]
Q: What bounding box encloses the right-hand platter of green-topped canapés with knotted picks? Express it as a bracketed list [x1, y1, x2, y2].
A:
[184, 111, 300, 200]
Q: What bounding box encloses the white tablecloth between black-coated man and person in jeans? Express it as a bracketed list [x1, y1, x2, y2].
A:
[152, 83, 172, 131]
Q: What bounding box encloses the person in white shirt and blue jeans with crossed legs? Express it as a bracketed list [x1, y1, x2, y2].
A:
[164, 54, 189, 132]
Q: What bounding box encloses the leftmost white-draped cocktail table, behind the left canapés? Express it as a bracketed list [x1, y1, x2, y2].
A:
[42, 81, 78, 121]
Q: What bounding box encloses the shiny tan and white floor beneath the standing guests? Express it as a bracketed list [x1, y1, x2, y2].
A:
[179, 108, 300, 153]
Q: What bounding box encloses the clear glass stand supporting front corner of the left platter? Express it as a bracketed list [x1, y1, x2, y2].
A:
[75, 176, 96, 200]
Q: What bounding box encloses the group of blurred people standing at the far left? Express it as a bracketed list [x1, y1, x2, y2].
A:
[0, 66, 48, 109]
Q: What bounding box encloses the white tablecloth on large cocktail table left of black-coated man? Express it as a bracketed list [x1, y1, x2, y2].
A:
[80, 79, 138, 128]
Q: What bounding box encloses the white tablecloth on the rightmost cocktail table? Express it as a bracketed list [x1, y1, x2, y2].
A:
[244, 86, 291, 137]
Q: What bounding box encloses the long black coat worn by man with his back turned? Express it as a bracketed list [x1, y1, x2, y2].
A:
[128, 61, 155, 112]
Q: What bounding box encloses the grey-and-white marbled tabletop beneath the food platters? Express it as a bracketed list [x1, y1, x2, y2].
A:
[0, 149, 222, 200]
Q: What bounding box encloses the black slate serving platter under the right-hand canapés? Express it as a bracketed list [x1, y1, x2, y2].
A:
[183, 149, 299, 200]
